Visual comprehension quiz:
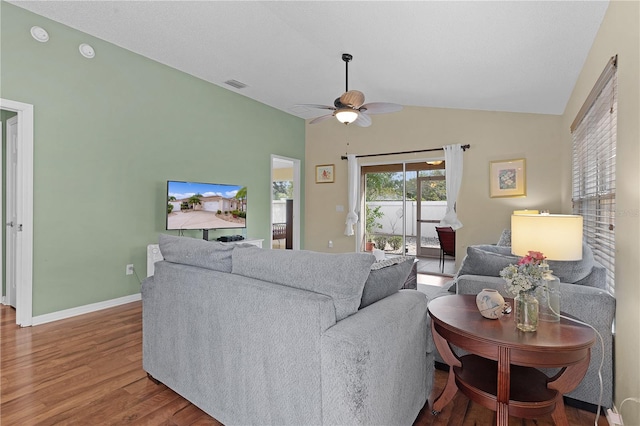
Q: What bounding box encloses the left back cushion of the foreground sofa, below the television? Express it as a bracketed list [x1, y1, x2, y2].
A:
[158, 234, 234, 272]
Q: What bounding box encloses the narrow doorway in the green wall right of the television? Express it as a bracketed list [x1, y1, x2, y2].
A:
[270, 155, 300, 250]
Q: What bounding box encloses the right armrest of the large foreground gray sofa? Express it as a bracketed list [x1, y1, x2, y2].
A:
[322, 290, 433, 425]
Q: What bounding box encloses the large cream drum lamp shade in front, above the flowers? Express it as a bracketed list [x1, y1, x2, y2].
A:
[511, 214, 582, 260]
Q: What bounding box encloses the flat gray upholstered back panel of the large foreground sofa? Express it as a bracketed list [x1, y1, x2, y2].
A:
[142, 262, 335, 425]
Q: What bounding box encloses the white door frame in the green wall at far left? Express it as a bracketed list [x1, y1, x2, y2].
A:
[0, 98, 33, 327]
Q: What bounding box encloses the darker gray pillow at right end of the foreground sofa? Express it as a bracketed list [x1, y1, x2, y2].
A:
[360, 256, 414, 309]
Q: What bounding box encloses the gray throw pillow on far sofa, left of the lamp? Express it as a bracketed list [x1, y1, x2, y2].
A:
[457, 245, 520, 277]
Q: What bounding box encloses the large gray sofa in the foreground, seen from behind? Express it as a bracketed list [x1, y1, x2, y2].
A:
[142, 235, 435, 425]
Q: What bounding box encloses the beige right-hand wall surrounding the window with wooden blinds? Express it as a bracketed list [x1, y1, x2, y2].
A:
[562, 1, 640, 425]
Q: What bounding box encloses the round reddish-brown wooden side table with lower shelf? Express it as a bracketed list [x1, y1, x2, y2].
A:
[429, 295, 596, 426]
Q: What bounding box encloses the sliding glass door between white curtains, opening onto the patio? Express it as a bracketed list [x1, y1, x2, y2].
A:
[360, 161, 446, 257]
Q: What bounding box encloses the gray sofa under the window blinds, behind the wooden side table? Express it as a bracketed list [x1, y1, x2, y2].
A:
[450, 242, 616, 407]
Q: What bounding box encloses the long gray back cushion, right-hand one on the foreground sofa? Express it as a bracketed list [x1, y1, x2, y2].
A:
[232, 247, 375, 321]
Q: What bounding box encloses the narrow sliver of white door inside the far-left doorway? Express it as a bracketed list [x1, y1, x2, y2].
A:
[5, 117, 18, 308]
